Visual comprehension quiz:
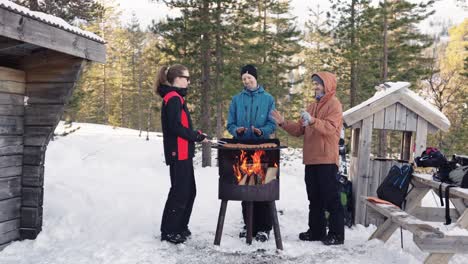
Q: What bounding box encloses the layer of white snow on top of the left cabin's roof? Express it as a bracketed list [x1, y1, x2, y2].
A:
[0, 0, 105, 43]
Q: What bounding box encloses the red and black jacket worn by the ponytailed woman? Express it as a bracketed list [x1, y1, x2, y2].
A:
[158, 85, 205, 165]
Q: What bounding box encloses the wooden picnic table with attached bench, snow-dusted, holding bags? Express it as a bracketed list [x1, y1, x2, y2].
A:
[362, 173, 468, 264]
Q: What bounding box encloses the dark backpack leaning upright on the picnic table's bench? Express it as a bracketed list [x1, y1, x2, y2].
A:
[377, 164, 413, 208]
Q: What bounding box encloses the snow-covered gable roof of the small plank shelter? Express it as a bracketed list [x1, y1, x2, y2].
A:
[343, 82, 450, 131]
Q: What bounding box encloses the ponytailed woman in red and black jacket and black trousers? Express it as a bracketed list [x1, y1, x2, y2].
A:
[156, 64, 206, 244]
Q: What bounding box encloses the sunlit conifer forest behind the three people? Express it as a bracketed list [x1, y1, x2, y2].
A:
[14, 0, 468, 159]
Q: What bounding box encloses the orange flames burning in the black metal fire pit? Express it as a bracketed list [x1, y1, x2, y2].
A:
[232, 150, 265, 184]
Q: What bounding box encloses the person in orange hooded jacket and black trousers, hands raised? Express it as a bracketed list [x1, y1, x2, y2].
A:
[271, 72, 344, 245]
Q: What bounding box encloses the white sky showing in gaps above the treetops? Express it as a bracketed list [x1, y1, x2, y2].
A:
[116, 0, 468, 31]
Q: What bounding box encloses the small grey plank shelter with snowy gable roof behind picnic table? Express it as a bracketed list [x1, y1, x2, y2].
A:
[343, 82, 450, 225]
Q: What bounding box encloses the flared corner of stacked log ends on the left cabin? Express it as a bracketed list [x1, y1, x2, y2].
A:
[20, 50, 85, 239]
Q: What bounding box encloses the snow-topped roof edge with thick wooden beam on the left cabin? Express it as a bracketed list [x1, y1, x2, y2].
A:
[0, 0, 106, 63]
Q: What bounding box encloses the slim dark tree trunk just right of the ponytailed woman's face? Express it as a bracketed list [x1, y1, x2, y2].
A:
[201, 0, 211, 167]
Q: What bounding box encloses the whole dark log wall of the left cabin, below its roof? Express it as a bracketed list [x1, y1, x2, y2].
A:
[0, 50, 85, 249]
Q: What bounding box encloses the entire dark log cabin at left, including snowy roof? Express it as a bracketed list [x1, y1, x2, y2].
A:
[0, 0, 105, 249]
